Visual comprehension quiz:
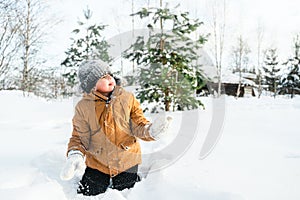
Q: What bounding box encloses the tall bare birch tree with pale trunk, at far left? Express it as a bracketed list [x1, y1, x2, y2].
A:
[16, 0, 59, 91]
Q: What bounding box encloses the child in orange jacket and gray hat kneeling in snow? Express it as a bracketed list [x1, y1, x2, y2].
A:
[61, 60, 172, 196]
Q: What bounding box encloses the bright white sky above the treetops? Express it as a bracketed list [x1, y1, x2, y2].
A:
[46, 0, 300, 72]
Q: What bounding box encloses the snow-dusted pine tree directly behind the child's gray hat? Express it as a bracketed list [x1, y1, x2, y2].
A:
[61, 8, 112, 95]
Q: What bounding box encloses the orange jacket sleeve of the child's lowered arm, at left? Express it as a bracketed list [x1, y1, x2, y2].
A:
[67, 104, 90, 155]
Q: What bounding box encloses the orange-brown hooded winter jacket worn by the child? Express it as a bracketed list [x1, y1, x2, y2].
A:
[68, 86, 154, 177]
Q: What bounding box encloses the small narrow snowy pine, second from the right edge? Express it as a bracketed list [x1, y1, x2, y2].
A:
[263, 48, 280, 98]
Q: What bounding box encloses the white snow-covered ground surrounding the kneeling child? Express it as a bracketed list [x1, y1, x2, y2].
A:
[0, 91, 300, 200]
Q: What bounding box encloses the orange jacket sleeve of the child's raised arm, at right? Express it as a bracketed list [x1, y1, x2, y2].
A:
[130, 94, 155, 141]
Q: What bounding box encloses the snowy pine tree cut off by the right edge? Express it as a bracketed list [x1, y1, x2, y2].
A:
[281, 34, 300, 98]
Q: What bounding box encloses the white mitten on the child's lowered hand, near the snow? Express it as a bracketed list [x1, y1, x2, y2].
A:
[60, 150, 86, 180]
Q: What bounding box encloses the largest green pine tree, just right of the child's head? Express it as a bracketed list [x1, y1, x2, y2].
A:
[124, 5, 206, 112]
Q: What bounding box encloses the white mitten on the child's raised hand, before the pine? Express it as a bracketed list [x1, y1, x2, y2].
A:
[149, 114, 173, 140]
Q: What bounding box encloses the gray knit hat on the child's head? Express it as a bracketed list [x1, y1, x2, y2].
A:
[78, 60, 111, 93]
